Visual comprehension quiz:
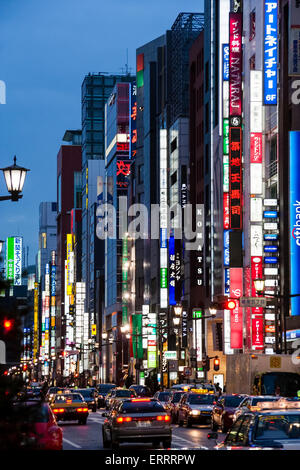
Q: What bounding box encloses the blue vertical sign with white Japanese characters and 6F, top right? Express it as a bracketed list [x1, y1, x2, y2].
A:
[264, 0, 278, 105]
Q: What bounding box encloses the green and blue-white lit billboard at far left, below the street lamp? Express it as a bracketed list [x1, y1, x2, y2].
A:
[6, 237, 23, 286]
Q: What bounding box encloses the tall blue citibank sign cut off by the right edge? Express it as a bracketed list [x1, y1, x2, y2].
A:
[289, 131, 300, 316]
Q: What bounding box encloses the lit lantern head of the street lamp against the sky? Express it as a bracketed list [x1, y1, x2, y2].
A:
[0, 156, 30, 202]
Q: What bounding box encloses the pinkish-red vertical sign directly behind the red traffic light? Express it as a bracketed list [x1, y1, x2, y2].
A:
[230, 268, 243, 349]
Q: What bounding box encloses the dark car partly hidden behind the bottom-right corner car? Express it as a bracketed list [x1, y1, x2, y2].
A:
[211, 394, 245, 432]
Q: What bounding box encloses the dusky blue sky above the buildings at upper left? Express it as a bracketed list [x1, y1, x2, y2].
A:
[0, 0, 203, 264]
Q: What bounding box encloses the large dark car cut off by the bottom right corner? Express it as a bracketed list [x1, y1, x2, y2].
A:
[207, 399, 300, 450]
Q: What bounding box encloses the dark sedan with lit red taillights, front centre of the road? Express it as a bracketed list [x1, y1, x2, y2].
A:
[102, 398, 172, 449]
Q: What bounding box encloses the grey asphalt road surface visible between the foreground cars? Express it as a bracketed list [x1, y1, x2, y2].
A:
[59, 410, 224, 450]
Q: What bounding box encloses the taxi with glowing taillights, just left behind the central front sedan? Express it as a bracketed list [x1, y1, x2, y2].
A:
[50, 392, 89, 424]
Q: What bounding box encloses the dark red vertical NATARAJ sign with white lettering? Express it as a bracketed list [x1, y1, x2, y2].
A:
[229, 13, 243, 116]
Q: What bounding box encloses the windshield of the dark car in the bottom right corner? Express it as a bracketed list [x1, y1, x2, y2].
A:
[254, 412, 300, 441]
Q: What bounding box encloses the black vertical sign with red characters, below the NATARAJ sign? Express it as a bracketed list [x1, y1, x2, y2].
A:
[229, 127, 243, 230]
